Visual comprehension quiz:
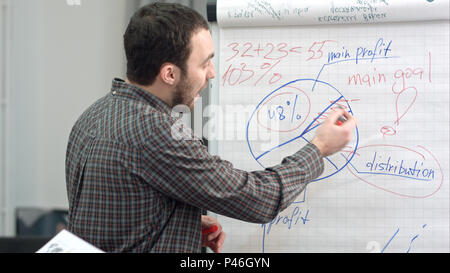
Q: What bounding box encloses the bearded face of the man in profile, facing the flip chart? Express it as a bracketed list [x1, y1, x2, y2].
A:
[173, 29, 215, 110]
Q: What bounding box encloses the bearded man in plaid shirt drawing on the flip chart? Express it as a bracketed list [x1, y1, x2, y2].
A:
[66, 3, 355, 252]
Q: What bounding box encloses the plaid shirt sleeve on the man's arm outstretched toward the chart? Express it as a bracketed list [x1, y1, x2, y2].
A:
[140, 117, 324, 223]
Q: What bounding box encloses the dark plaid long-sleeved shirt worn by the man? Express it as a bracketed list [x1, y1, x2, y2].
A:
[66, 79, 324, 252]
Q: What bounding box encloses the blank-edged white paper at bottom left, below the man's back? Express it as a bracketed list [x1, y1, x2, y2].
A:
[36, 230, 104, 253]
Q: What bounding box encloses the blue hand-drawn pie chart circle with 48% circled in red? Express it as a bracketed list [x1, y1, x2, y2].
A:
[246, 79, 359, 181]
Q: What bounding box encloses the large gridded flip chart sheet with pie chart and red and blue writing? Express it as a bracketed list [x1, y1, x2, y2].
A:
[209, 1, 450, 253]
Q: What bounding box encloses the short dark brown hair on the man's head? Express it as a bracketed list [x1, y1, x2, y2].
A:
[124, 3, 209, 85]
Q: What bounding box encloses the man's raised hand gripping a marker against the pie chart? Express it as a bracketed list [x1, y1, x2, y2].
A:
[311, 109, 357, 157]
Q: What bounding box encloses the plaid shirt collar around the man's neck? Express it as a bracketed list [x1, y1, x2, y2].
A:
[111, 78, 171, 114]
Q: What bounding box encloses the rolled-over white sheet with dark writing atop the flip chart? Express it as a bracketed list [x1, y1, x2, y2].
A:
[217, 0, 449, 28]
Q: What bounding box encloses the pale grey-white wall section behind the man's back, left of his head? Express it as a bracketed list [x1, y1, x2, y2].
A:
[9, 0, 133, 234]
